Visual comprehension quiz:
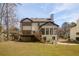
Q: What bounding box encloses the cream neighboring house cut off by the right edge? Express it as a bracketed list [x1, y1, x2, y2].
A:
[70, 20, 79, 41]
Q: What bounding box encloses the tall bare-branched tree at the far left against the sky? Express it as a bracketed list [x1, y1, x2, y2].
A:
[0, 3, 17, 40]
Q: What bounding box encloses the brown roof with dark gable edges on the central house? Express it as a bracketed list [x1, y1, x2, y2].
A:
[21, 18, 59, 27]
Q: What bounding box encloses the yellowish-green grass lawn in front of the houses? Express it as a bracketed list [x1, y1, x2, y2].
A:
[0, 41, 79, 56]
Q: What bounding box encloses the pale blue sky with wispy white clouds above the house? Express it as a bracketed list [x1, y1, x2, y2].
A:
[17, 3, 79, 26]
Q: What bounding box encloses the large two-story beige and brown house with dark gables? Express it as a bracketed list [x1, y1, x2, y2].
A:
[20, 15, 58, 43]
